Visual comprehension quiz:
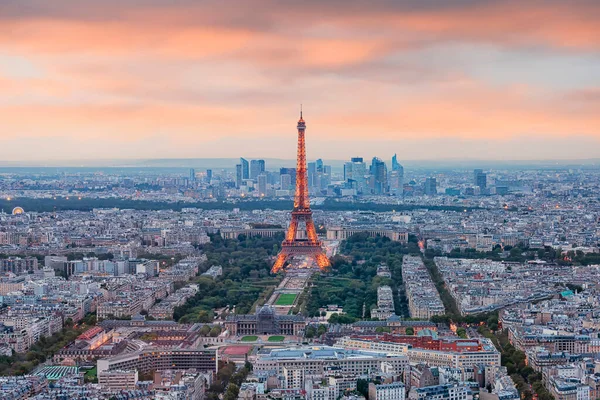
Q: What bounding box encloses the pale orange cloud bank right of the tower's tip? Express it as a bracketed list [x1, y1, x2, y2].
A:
[314, 82, 600, 140]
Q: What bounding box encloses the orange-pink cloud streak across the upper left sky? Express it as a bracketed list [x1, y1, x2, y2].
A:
[0, 19, 253, 57]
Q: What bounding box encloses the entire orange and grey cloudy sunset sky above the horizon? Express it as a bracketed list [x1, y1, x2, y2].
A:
[0, 0, 600, 161]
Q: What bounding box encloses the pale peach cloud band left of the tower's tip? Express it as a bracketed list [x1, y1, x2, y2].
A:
[0, 103, 290, 144]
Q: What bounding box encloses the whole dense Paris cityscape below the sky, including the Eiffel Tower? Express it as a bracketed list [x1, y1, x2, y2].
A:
[0, 110, 600, 400]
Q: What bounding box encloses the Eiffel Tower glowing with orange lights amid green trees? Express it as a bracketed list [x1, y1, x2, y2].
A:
[271, 107, 330, 273]
